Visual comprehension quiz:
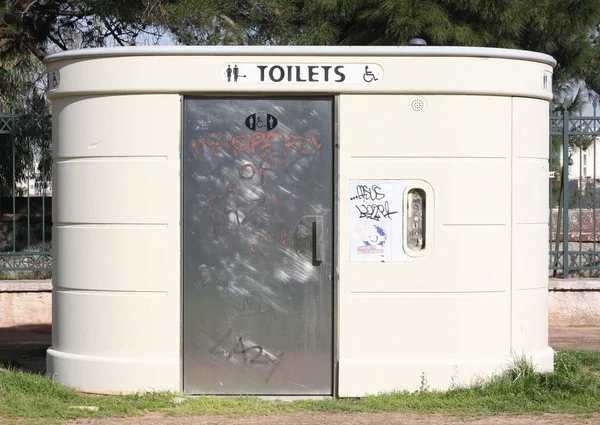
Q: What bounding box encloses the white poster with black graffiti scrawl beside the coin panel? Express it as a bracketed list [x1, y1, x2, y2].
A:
[350, 180, 407, 262]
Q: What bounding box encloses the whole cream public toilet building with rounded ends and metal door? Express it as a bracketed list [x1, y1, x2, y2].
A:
[45, 46, 556, 397]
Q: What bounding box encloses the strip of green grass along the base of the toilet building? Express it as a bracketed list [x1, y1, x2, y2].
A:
[0, 351, 600, 423]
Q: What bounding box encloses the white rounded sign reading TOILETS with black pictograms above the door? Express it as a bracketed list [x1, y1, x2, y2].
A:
[221, 63, 383, 84]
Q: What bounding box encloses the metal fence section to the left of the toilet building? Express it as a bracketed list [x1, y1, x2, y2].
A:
[0, 113, 52, 272]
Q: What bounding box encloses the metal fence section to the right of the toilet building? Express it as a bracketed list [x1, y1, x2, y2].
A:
[549, 97, 600, 278]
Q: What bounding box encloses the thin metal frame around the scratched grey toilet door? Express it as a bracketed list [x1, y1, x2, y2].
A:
[179, 92, 340, 399]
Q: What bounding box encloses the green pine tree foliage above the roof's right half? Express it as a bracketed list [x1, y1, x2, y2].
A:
[310, 0, 600, 90]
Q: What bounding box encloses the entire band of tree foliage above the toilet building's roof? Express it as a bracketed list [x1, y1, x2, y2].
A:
[0, 0, 600, 91]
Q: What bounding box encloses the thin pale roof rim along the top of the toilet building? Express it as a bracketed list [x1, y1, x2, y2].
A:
[44, 46, 556, 67]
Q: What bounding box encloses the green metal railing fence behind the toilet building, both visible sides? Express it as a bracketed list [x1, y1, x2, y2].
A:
[0, 106, 600, 278]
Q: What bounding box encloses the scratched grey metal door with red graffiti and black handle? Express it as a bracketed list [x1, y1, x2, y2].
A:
[182, 97, 334, 395]
